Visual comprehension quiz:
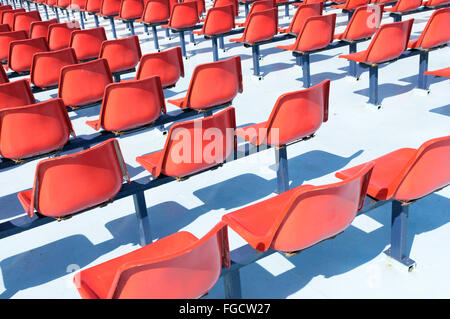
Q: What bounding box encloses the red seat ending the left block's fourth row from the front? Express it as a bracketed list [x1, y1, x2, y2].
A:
[136, 47, 184, 88]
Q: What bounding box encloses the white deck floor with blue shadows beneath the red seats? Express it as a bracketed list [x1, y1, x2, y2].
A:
[0, 2, 450, 298]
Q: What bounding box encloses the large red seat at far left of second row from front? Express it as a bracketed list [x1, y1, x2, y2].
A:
[17, 139, 129, 218]
